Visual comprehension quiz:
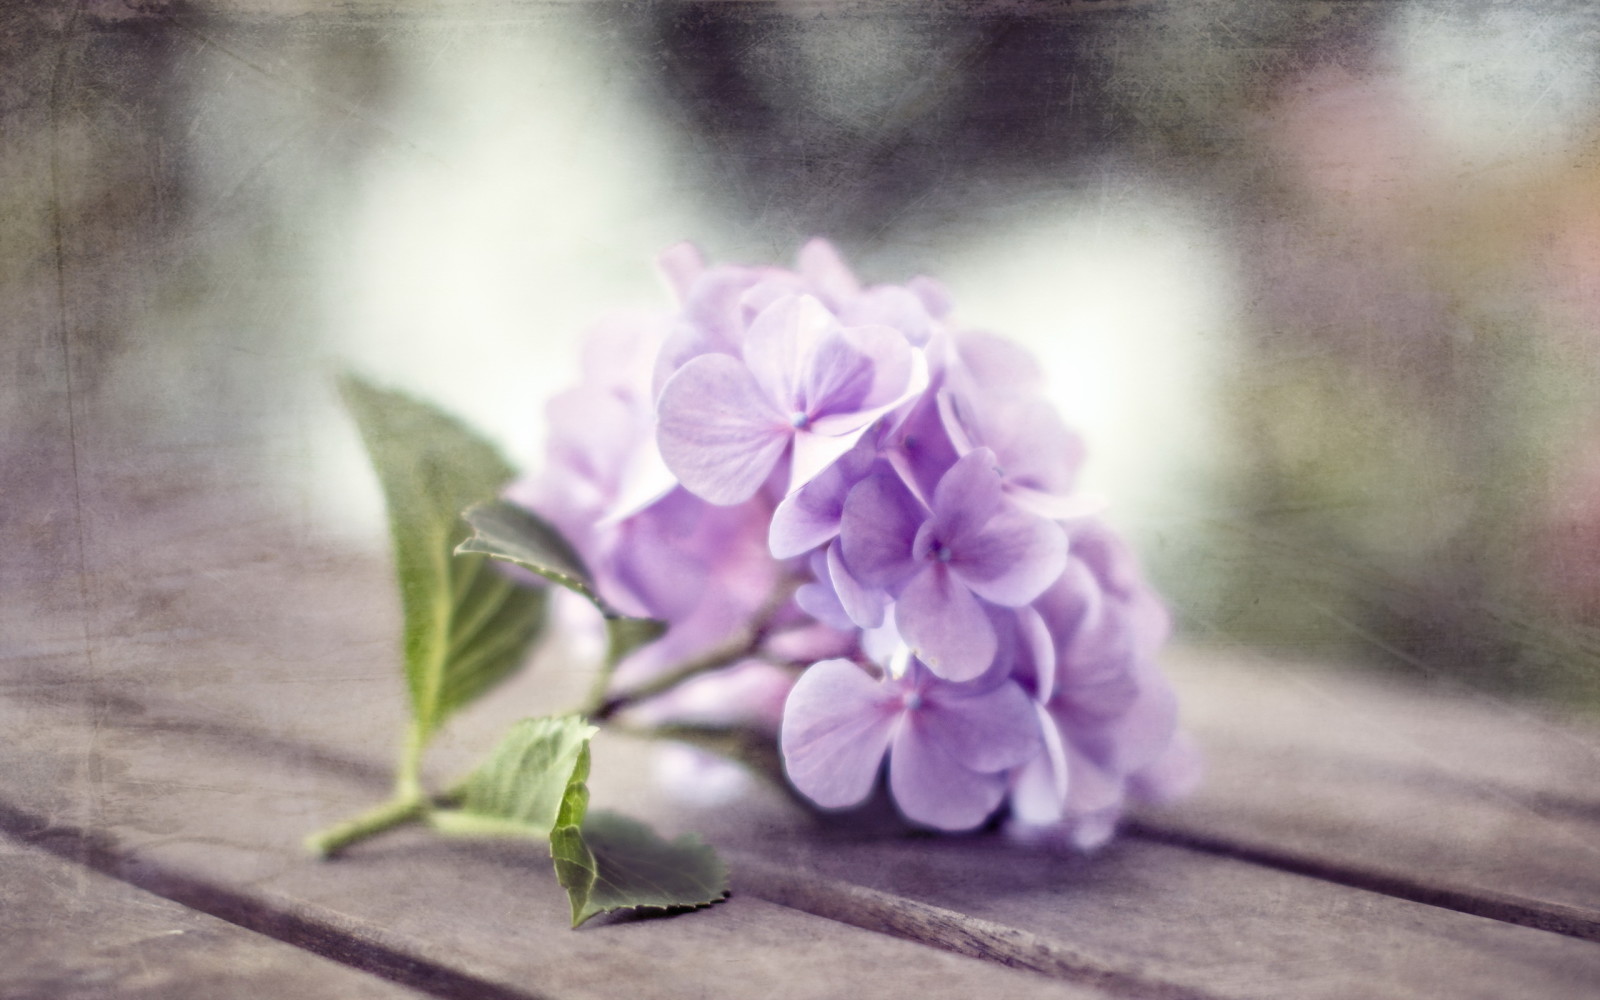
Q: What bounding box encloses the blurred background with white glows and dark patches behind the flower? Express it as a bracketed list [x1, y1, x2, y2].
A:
[9, 0, 1600, 709]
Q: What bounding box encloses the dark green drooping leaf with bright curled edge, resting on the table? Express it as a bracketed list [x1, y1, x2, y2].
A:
[550, 806, 728, 926]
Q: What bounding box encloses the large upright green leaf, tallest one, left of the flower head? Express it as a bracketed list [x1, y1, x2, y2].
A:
[339, 374, 547, 748]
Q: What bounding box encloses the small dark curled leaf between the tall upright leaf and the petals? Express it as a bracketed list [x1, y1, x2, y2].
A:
[456, 501, 667, 664]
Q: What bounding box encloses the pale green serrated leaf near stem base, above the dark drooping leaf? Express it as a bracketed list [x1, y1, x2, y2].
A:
[434, 715, 598, 840]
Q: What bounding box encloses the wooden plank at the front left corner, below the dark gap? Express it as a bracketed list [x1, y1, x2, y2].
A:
[0, 837, 422, 1000]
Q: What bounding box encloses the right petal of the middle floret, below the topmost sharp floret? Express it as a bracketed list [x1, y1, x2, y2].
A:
[941, 505, 1067, 608]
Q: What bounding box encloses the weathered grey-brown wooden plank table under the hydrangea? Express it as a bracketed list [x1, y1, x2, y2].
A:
[9, 450, 1600, 998]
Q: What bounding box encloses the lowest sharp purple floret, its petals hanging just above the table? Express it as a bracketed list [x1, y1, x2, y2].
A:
[779, 659, 1040, 830]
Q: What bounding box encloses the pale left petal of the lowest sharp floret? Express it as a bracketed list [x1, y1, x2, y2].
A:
[778, 659, 901, 810]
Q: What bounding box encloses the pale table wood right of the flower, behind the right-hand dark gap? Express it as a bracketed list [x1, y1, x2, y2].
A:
[1146, 651, 1600, 921]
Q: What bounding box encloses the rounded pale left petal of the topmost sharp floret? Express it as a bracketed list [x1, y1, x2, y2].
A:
[656, 354, 792, 504]
